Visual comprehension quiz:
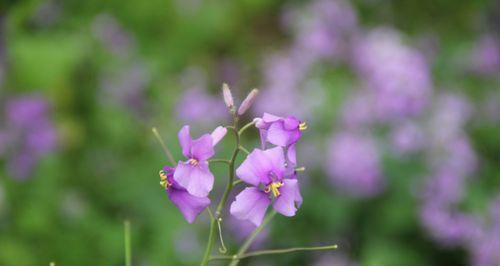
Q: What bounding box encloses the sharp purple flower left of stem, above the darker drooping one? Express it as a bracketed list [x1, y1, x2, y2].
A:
[174, 126, 227, 197]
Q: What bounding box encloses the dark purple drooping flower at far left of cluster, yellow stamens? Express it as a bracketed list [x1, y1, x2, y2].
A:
[160, 166, 210, 223]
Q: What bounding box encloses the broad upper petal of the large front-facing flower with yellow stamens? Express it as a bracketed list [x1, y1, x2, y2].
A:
[236, 147, 285, 186]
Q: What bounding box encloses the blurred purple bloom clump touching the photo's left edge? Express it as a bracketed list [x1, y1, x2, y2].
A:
[0, 96, 57, 179]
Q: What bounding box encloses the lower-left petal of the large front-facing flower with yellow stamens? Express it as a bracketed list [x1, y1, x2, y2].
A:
[229, 187, 271, 226]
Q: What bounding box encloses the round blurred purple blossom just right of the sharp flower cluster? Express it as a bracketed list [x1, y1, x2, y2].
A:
[326, 132, 382, 196]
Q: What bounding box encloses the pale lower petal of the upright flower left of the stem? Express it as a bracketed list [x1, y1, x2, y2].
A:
[174, 162, 214, 197]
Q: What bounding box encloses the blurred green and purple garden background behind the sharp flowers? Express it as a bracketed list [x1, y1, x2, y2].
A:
[0, 0, 500, 266]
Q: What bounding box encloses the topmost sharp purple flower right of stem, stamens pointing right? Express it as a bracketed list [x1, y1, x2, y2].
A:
[255, 113, 307, 164]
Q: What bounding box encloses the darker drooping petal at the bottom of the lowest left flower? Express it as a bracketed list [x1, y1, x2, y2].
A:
[167, 189, 210, 223]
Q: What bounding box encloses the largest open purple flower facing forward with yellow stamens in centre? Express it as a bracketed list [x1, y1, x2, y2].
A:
[230, 147, 302, 226]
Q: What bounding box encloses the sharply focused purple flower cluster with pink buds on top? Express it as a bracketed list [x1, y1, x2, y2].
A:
[160, 84, 307, 226]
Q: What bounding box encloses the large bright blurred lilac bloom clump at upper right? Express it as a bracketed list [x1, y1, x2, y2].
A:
[354, 28, 432, 121]
